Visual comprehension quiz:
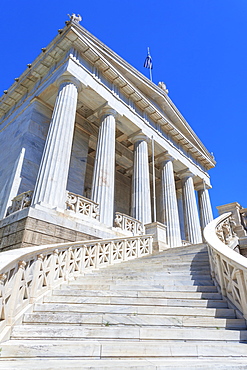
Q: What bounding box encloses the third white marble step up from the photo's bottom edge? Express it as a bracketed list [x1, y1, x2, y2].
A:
[11, 324, 247, 342]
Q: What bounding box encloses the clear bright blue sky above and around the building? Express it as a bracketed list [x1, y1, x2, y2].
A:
[0, 0, 247, 215]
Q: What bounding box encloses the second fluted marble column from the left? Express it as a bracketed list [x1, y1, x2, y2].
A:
[92, 108, 116, 226]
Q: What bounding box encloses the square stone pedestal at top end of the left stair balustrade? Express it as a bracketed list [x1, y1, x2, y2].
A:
[145, 222, 169, 251]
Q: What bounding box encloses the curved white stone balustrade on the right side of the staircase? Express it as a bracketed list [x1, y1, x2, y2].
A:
[204, 212, 247, 319]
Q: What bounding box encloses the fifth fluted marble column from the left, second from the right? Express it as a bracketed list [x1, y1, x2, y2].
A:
[180, 171, 202, 244]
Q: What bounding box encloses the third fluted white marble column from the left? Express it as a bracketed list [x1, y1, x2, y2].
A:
[131, 133, 152, 225]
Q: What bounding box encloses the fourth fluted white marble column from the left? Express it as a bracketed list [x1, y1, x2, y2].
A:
[159, 154, 182, 247]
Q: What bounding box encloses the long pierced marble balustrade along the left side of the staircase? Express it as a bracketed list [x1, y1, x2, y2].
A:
[0, 235, 152, 339]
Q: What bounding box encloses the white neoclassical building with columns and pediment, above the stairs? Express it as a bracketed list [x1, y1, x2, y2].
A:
[0, 16, 215, 250]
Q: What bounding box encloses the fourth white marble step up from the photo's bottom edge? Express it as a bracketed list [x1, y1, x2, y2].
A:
[23, 312, 246, 329]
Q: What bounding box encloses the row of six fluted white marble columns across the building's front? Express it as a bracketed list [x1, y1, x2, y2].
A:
[32, 76, 213, 246]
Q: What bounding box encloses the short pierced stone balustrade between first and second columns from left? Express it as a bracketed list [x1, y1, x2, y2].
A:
[66, 192, 99, 220]
